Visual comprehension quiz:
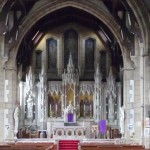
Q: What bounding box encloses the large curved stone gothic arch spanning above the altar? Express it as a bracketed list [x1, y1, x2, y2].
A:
[9, 1, 124, 67]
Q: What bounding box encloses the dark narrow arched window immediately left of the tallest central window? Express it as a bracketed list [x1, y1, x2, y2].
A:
[47, 38, 57, 70]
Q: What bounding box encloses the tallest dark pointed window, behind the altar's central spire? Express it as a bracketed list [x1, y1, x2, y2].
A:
[64, 29, 78, 68]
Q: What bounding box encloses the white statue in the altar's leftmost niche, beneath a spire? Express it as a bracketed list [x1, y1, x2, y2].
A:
[27, 94, 33, 119]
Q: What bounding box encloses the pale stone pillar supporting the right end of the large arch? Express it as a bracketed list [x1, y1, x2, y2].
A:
[121, 47, 135, 142]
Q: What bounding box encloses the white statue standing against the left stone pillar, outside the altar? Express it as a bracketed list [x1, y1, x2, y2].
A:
[14, 105, 20, 134]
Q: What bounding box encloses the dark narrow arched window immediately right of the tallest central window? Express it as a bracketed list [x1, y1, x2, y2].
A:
[85, 38, 95, 71]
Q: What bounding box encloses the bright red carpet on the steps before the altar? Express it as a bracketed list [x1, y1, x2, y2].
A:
[59, 140, 79, 150]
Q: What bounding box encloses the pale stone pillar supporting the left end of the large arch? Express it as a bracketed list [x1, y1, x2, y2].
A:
[3, 66, 19, 141]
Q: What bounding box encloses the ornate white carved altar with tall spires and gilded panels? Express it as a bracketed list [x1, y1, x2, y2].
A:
[20, 54, 124, 139]
